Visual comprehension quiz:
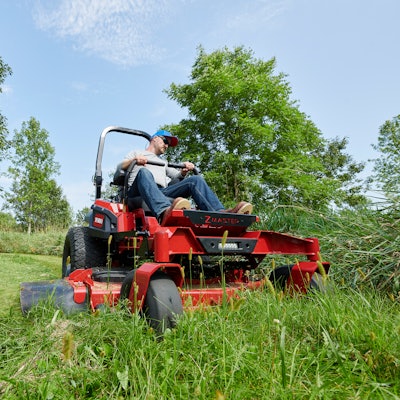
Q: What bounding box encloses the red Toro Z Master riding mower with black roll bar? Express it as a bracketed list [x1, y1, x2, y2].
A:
[21, 127, 329, 332]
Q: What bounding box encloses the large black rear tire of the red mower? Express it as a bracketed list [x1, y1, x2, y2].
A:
[61, 226, 107, 278]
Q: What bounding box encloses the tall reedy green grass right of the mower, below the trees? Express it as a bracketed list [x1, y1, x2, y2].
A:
[262, 206, 400, 299]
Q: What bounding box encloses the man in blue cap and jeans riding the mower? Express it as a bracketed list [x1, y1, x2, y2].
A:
[120, 130, 253, 225]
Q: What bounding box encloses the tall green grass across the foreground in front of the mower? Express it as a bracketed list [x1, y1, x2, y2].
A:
[0, 289, 400, 400]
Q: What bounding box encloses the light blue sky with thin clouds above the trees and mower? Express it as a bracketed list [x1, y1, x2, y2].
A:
[0, 0, 400, 211]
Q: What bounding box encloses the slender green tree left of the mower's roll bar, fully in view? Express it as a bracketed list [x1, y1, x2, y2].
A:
[3, 117, 72, 233]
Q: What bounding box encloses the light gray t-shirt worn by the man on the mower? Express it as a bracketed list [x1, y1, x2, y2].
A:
[124, 150, 182, 187]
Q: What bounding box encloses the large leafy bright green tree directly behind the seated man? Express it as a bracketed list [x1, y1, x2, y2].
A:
[165, 47, 363, 208]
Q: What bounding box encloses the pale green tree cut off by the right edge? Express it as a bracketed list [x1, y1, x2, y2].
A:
[370, 115, 400, 203]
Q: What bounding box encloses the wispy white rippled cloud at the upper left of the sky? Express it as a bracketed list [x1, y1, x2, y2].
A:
[34, 0, 169, 66]
